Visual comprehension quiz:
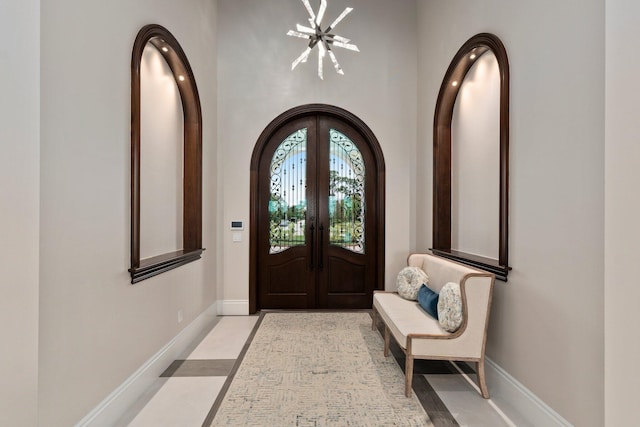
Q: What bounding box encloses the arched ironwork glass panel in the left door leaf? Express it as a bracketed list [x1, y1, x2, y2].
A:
[269, 128, 307, 254]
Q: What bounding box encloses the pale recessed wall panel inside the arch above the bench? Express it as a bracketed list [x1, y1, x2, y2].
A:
[451, 52, 500, 259]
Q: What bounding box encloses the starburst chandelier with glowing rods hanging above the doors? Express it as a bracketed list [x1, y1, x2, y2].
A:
[287, 0, 360, 80]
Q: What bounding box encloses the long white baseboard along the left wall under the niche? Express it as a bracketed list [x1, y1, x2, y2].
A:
[75, 303, 217, 427]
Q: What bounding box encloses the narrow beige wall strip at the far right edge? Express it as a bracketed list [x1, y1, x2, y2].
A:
[605, 0, 640, 426]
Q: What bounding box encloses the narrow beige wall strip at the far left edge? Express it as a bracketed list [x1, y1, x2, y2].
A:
[0, 0, 40, 427]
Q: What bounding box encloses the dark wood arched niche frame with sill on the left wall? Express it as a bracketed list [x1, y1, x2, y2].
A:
[129, 24, 204, 283]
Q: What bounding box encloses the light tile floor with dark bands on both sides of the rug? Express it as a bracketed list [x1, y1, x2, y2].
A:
[117, 316, 516, 427]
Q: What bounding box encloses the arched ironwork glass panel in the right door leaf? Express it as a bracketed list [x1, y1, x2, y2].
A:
[329, 129, 365, 254]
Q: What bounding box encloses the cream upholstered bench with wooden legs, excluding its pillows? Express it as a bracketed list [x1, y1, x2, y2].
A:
[372, 254, 495, 399]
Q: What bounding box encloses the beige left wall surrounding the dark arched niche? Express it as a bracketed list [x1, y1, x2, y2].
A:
[39, 0, 217, 426]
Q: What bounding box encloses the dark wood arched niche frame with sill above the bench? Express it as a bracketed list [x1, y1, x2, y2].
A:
[432, 33, 510, 281]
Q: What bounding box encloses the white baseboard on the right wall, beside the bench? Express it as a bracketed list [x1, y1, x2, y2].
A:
[485, 358, 572, 427]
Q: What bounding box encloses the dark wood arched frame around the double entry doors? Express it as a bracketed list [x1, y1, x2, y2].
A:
[249, 104, 385, 313]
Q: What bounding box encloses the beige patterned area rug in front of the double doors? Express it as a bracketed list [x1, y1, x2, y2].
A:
[210, 312, 433, 427]
